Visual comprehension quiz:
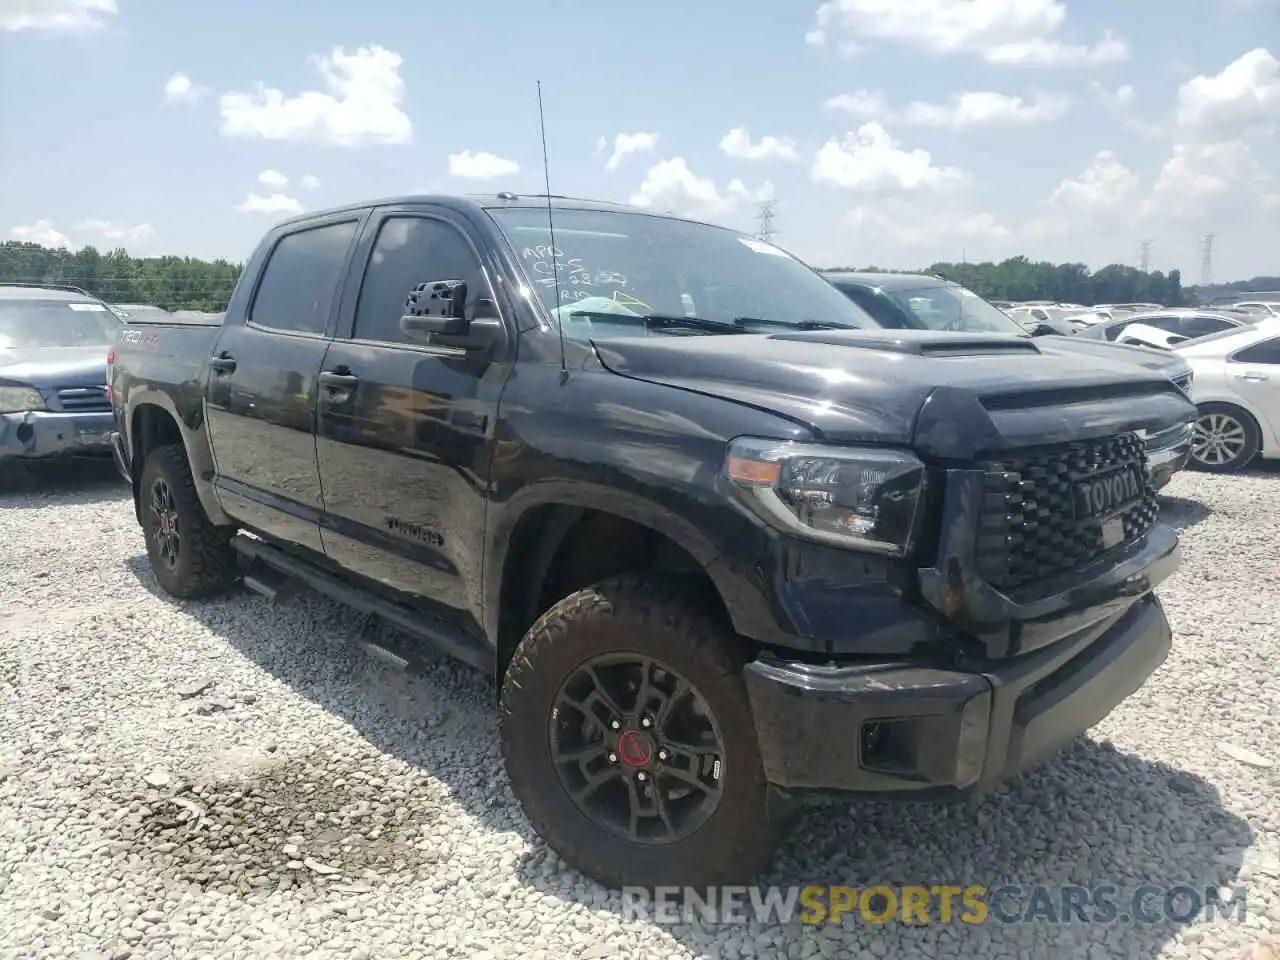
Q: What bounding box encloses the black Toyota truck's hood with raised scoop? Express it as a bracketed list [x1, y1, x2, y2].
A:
[593, 330, 1196, 460]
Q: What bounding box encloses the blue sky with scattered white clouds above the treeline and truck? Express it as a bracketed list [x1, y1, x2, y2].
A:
[0, 0, 1280, 283]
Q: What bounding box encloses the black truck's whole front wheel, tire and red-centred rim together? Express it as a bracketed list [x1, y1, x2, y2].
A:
[500, 579, 788, 888]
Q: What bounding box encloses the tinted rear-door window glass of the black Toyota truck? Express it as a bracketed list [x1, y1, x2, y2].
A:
[248, 220, 360, 334]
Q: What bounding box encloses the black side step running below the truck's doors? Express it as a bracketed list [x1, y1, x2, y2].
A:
[232, 534, 495, 675]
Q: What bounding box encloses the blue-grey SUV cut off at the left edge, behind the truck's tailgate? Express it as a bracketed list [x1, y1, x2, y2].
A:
[0, 283, 124, 463]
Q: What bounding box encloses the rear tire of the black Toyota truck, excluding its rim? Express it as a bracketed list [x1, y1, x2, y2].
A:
[138, 444, 239, 600]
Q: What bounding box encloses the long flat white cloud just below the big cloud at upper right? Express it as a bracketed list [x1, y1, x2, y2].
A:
[826, 90, 1071, 132]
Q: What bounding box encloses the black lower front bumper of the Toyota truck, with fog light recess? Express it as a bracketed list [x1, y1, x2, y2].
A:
[746, 594, 1172, 800]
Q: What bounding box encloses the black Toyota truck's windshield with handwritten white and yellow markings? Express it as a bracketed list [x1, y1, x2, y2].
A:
[489, 207, 878, 338]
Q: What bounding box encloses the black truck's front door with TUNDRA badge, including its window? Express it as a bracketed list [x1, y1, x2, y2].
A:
[316, 206, 506, 627]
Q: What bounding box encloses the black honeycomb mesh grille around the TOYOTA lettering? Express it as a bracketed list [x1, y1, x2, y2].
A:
[977, 434, 1158, 589]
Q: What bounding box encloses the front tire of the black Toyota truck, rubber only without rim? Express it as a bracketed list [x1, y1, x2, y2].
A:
[499, 577, 795, 890]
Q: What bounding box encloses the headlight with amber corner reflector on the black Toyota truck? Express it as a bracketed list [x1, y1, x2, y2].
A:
[724, 438, 924, 557]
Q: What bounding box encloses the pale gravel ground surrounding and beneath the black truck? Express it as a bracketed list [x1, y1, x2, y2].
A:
[0, 470, 1280, 960]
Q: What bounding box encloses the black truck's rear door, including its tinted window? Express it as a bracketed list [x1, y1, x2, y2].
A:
[205, 212, 362, 552]
